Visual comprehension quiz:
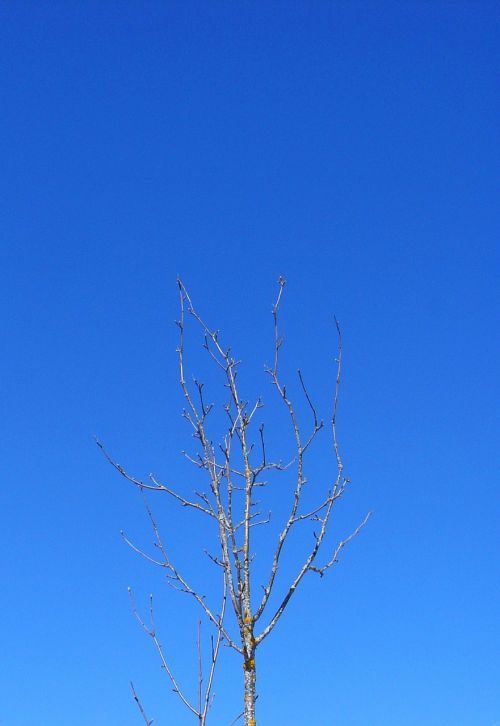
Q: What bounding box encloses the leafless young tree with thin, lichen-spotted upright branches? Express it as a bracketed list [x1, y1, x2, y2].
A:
[98, 277, 371, 726]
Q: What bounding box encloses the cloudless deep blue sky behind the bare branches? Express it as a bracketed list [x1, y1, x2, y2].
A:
[0, 0, 500, 726]
